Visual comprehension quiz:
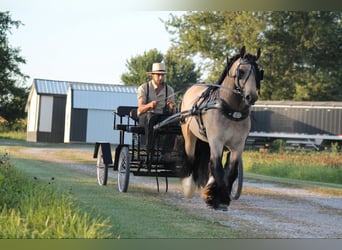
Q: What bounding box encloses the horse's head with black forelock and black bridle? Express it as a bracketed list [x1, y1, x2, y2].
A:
[228, 46, 263, 105]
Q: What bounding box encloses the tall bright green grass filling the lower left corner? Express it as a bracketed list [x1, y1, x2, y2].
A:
[0, 158, 111, 239]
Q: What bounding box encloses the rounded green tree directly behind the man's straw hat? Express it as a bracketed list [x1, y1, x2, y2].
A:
[121, 48, 200, 95]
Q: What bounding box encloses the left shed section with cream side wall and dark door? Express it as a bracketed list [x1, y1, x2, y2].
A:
[26, 79, 69, 142]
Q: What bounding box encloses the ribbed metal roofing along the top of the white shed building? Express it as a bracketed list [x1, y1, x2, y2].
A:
[33, 79, 138, 95]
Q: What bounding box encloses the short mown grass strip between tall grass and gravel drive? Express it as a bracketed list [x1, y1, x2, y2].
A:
[8, 159, 239, 239]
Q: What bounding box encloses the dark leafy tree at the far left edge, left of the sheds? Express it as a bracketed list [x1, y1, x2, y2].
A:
[0, 12, 28, 125]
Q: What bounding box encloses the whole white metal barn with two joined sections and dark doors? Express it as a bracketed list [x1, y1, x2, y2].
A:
[26, 79, 137, 144]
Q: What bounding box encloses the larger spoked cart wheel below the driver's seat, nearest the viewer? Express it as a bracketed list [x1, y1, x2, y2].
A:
[118, 147, 130, 192]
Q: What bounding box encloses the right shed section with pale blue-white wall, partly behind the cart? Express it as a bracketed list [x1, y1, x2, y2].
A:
[64, 83, 137, 144]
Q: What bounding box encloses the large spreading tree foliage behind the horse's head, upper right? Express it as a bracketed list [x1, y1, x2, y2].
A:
[164, 11, 342, 101]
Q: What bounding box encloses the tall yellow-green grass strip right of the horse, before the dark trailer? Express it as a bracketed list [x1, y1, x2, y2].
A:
[243, 151, 342, 184]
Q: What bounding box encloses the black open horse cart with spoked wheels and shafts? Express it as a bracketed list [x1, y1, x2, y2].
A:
[93, 106, 243, 200]
